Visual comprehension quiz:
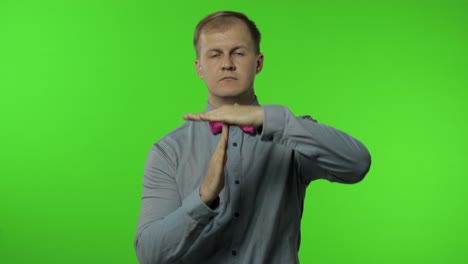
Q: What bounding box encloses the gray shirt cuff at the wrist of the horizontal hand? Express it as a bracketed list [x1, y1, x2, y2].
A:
[260, 105, 287, 141]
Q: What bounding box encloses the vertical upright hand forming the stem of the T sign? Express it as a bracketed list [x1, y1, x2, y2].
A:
[200, 124, 229, 206]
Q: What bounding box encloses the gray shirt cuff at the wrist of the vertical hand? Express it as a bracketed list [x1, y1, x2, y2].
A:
[182, 189, 218, 224]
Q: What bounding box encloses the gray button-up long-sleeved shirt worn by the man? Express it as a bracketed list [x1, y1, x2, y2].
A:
[135, 101, 370, 264]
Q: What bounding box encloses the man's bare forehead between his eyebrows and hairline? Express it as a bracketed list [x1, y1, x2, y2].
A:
[199, 20, 253, 50]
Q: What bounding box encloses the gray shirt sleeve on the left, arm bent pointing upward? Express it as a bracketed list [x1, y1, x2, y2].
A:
[135, 141, 218, 264]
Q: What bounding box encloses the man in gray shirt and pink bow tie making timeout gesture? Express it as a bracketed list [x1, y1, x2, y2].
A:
[135, 12, 370, 264]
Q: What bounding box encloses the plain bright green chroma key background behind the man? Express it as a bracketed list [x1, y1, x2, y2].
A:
[0, 0, 468, 264]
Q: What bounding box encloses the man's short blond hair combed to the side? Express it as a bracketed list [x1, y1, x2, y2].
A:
[193, 11, 261, 58]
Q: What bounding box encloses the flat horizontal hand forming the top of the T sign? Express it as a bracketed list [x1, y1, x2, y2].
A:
[183, 104, 263, 127]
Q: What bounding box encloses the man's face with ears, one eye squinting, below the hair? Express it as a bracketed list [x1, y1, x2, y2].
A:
[195, 21, 263, 101]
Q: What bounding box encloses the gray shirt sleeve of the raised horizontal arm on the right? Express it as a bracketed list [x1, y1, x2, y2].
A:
[261, 105, 371, 184]
